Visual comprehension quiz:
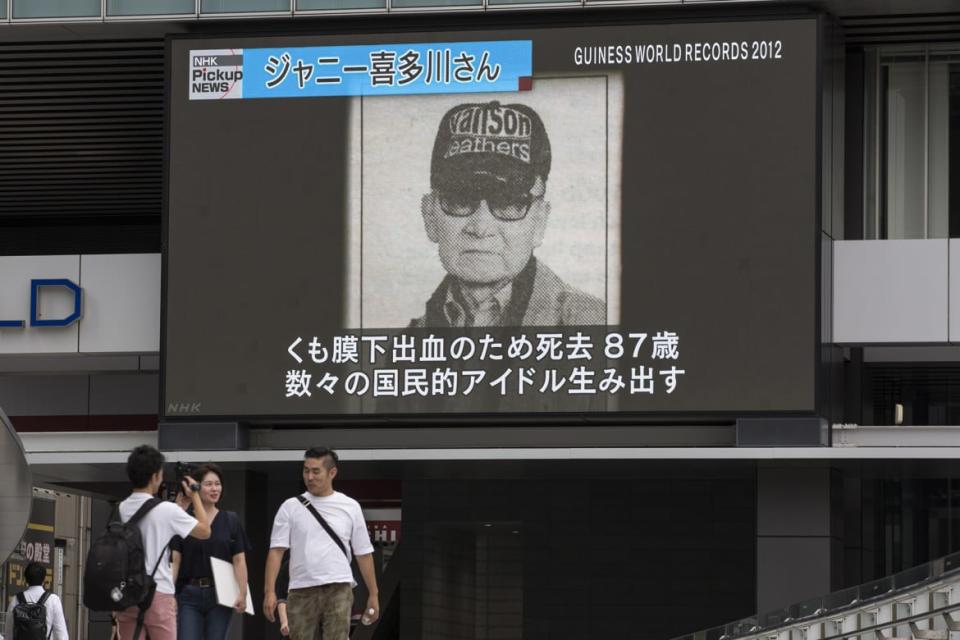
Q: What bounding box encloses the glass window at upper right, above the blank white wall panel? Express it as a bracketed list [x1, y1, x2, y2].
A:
[864, 49, 960, 239]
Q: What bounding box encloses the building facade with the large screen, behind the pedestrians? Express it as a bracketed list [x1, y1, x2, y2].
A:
[0, 0, 960, 640]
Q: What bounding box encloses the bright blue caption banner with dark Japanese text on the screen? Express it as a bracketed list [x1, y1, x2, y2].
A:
[242, 40, 533, 98]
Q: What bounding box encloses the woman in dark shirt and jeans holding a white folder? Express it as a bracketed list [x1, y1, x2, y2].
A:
[170, 463, 250, 640]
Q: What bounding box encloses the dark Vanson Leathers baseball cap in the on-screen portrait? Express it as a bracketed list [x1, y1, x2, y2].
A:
[430, 100, 550, 192]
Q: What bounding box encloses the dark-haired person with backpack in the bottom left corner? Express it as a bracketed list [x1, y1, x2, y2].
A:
[0, 562, 70, 640]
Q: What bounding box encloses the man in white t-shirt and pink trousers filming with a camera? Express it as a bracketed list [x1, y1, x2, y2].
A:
[117, 445, 210, 640]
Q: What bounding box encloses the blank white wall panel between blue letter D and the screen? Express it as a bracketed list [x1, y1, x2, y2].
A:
[80, 253, 161, 353]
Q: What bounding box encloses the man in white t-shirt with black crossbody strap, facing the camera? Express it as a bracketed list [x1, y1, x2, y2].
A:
[263, 447, 380, 640]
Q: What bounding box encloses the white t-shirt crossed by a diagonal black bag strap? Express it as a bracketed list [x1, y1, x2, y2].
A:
[270, 491, 373, 589]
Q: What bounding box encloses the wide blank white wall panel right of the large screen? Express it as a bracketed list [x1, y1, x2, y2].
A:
[833, 239, 948, 343]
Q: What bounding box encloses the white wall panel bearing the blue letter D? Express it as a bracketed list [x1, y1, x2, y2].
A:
[0, 256, 83, 353]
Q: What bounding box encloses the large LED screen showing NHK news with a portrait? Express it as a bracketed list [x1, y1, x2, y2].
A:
[163, 19, 818, 419]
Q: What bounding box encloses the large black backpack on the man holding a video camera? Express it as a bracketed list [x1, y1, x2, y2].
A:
[83, 498, 166, 637]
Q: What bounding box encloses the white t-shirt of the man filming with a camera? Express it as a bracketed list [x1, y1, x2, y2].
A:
[120, 492, 197, 594]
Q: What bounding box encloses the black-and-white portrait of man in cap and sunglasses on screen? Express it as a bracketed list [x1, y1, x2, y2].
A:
[347, 76, 622, 329]
